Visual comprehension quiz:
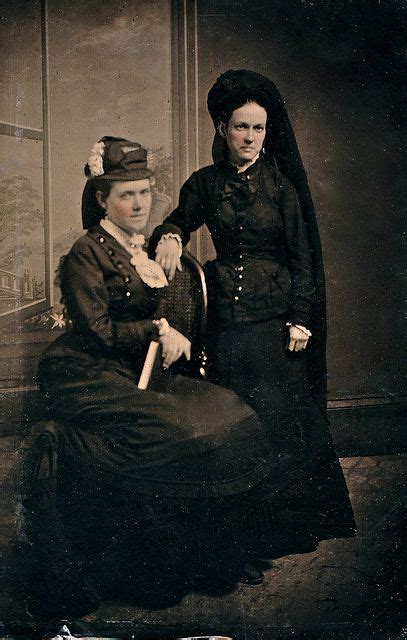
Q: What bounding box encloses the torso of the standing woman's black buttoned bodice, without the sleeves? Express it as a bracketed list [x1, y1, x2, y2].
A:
[206, 163, 291, 322]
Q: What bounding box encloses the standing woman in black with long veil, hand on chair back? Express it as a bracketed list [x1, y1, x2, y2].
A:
[150, 70, 355, 568]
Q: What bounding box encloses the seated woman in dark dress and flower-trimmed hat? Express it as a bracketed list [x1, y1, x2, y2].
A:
[15, 137, 280, 628]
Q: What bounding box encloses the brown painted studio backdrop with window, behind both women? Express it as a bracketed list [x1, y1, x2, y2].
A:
[0, 0, 407, 636]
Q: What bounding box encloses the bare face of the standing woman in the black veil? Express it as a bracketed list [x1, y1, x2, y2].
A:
[220, 102, 267, 167]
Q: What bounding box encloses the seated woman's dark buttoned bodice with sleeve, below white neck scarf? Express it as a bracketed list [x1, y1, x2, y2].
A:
[43, 225, 161, 368]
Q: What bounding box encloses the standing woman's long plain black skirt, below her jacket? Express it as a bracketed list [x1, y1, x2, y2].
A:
[209, 318, 356, 554]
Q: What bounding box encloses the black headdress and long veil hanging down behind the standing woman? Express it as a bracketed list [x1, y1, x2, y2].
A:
[208, 69, 327, 411]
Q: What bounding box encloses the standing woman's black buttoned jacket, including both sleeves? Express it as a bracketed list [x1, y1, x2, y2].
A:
[150, 158, 315, 326]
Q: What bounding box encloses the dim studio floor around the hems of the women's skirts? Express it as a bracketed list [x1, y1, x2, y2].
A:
[0, 437, 407, 640]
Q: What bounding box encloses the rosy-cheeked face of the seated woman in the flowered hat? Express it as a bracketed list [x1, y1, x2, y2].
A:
[97, 178, 152, 234]
